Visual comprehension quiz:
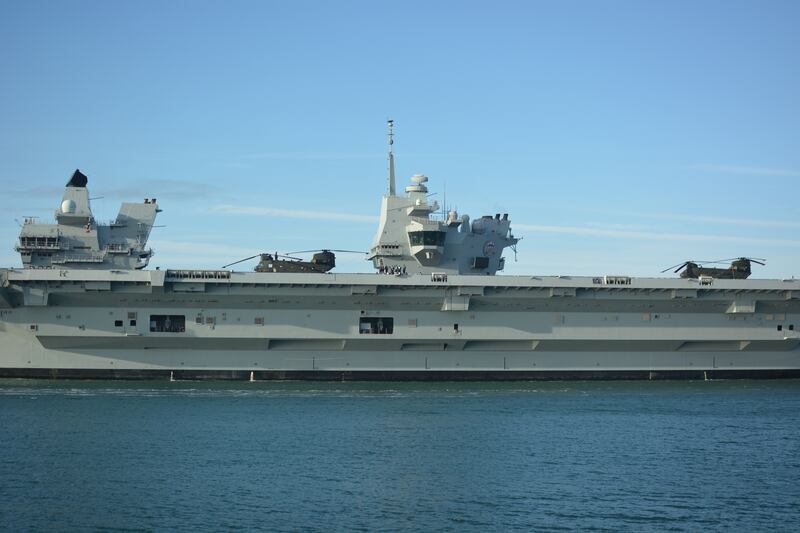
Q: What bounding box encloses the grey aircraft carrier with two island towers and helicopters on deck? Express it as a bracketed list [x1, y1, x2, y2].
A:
[0, 122, 800, 380]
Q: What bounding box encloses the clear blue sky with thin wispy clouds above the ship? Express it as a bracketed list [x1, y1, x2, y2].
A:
[0, 0, 800, 277]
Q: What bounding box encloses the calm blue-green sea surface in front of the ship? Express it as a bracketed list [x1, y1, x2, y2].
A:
[0, 380, 800, 531]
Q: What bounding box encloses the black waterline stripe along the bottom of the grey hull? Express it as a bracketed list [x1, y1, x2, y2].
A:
[0, 368, 800, 381]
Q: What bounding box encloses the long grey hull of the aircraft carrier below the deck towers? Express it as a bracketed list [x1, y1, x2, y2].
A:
[0, 270, 800, 380]
